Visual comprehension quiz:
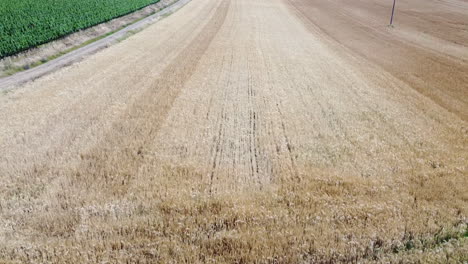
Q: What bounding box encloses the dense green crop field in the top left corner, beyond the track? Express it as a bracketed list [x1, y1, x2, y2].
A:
[0, 0, 159, 58]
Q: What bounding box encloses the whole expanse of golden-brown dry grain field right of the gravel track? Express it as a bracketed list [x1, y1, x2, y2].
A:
[0, 0, 468, 263]
